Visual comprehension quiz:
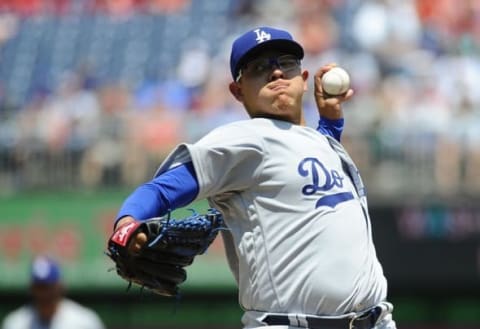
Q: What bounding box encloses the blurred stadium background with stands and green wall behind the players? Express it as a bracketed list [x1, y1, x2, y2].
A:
[0, 0, 480, 329]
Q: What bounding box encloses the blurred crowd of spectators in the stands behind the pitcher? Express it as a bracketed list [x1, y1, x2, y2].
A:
[0, 0, 480, 197]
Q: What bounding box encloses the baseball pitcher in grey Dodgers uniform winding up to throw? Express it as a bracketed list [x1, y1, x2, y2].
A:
[109, 27, 395, 329]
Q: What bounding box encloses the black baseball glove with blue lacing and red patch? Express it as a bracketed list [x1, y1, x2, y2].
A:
[106, 209, 225, 296]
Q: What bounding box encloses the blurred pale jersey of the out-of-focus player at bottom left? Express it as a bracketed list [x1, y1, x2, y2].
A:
[2, 299, 105, 329]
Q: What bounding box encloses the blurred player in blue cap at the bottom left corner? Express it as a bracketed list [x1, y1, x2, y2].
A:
[2, 256, 104, 329]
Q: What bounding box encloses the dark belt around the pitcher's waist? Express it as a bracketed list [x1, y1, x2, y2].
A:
[262, 306, 382, 329]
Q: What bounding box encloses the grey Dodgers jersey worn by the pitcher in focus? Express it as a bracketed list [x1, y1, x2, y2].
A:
[157, 118, 387, 327]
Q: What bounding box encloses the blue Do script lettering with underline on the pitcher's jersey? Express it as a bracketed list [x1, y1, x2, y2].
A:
[298, 157, 353, 208]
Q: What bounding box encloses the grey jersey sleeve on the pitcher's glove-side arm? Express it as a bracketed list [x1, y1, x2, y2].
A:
[156, 124, 264, 199]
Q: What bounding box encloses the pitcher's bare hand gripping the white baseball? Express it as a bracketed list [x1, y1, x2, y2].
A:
[314, 63, 354, 119]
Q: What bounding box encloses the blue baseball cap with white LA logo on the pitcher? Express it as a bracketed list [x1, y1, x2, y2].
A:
[230, 26, 304, 80]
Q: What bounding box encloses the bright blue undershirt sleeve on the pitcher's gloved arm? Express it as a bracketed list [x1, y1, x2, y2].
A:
[115, 162, 199, 222]
